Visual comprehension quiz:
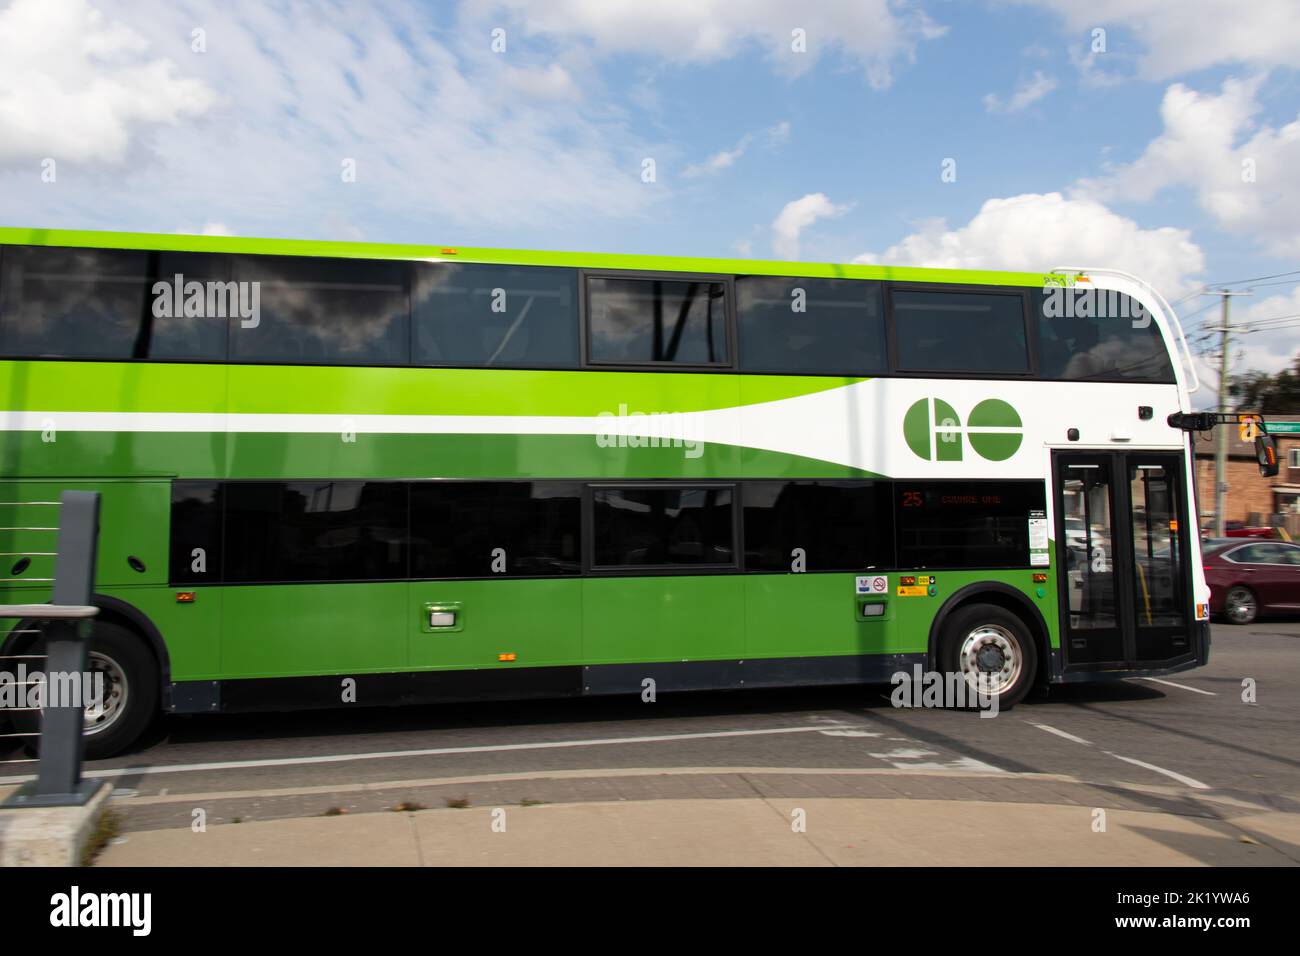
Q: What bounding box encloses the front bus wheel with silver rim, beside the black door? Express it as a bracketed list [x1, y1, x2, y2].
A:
[940, 604, 1039, 709]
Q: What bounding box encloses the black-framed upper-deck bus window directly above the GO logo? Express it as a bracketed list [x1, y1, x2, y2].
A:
[891, 289, 1030, 373]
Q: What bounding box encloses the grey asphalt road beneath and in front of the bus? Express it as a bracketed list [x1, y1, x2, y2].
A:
[0, 620, 1300, 813]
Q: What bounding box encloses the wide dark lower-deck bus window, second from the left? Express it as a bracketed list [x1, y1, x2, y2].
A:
[224, 481, 407, 584]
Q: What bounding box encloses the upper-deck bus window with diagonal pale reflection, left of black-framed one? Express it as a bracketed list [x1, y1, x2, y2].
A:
[411, 263, 579, 368]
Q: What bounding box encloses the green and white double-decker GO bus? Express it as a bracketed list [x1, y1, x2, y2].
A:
[0, 229, 1209, 756]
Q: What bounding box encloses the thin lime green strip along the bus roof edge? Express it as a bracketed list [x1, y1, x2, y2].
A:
[0, 228, 1044, 286]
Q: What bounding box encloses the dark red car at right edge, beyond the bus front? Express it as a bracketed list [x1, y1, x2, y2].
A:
[1201, 538, 1300, 624]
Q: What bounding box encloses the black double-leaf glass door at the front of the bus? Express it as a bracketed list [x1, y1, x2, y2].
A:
[1053, 451, 1195, 671]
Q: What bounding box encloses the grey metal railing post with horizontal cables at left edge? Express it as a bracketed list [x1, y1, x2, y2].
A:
[0, 492, 99, 806]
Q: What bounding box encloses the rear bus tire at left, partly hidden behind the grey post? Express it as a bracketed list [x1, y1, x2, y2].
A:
[13, 620, 159, 760]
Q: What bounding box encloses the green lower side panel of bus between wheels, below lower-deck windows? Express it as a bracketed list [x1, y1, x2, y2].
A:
[0, 570, 1060, 680]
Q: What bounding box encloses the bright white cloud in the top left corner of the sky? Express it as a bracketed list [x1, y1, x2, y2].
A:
[0, 0, 216, 165]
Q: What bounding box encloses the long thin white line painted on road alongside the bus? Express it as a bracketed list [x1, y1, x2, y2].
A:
[0, 724, 848, 784]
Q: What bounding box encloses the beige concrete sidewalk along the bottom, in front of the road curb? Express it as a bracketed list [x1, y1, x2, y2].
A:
[98, 797, 1300, 866]
